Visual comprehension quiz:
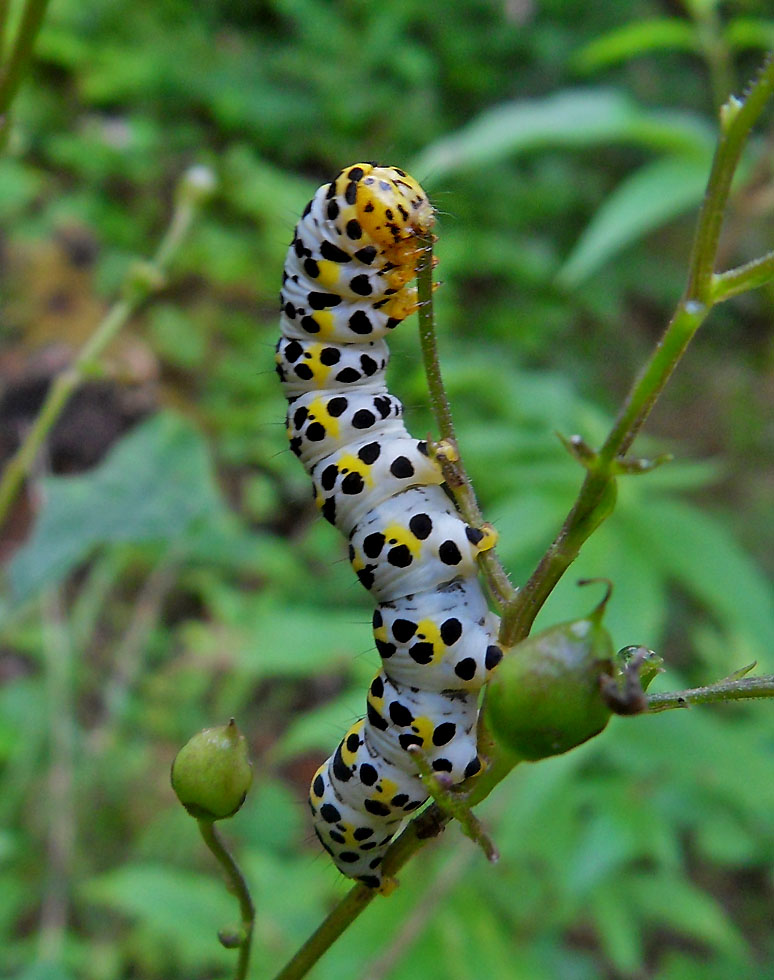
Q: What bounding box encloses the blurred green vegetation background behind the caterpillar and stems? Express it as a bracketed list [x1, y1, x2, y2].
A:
[0, 0, 774, 980]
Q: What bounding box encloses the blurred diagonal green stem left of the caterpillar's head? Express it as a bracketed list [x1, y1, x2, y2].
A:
[0, 176, 209, 526]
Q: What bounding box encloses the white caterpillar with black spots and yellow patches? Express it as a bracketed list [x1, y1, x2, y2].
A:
[276, 163, 502, 888]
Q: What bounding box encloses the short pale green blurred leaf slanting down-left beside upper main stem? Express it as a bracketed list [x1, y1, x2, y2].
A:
[557, 151, 712, 288]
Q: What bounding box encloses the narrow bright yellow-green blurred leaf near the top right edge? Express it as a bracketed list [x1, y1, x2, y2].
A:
[571, 17, 700, 73]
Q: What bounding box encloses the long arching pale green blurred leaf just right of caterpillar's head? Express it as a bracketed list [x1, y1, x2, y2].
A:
[409, 89, 712, 186]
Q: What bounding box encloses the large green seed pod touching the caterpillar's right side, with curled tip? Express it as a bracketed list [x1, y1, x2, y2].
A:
[484, 583, 616, 761]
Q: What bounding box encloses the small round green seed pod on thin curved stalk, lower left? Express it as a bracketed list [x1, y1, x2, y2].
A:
[172, 718, 253, 820]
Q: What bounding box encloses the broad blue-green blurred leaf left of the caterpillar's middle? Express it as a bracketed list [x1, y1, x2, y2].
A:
[9, 412, 223, 602]
